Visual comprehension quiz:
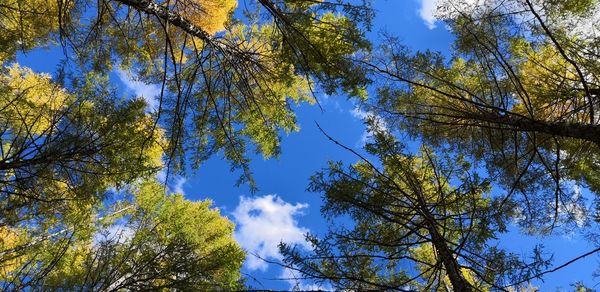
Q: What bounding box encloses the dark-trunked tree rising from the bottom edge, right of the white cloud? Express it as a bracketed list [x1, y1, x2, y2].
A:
[281, 132, 548, 291]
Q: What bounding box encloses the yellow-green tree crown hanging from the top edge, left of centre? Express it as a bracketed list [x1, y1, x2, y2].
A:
[43, 0, 370, 183]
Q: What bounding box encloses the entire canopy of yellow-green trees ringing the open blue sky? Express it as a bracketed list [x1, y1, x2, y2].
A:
[0, 0, 600, 291]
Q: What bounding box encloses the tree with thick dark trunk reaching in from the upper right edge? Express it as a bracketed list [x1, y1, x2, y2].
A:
[371, 0, 600, 232]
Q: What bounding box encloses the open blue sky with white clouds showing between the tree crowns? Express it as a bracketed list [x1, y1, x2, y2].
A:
[19, 0, 600, 291]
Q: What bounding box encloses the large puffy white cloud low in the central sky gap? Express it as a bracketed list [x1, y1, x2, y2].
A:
[233, 195, 309, 271]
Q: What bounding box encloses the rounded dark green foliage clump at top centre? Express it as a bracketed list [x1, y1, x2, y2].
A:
[278, 5, 370, 98]
